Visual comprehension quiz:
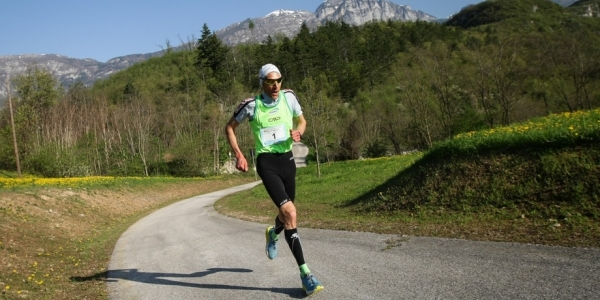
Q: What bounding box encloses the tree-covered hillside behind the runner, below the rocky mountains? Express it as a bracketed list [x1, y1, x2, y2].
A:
[0, 0, 600, 177]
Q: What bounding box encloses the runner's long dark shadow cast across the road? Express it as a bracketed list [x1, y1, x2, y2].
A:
[70, 268, 305, 299]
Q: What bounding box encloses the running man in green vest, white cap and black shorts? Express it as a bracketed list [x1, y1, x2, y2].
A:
[225, 64, 323, 295]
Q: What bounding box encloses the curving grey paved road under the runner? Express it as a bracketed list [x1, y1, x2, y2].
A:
[108, 183, 600, 299]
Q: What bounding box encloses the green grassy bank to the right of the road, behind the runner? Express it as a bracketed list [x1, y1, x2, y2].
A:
[215, 109, 600, 247]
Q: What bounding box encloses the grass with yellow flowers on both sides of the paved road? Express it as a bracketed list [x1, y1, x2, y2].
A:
[0, 110, 600, 299]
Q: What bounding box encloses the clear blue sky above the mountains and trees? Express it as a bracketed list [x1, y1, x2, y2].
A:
[0, 0, 481, 62]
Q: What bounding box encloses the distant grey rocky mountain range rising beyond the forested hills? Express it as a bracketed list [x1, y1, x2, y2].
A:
[0, 0, 574, 104]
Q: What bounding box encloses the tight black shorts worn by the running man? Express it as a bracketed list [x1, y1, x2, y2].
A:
[256, 151, 296, 207]
